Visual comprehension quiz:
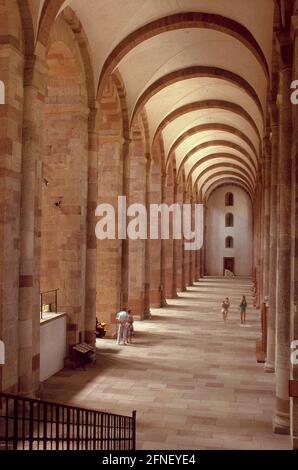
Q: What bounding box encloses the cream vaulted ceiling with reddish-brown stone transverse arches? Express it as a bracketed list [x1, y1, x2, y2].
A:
[31, 0, 274, 200]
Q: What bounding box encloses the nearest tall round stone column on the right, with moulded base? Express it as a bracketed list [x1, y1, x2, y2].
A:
[274, 37, 292, 434]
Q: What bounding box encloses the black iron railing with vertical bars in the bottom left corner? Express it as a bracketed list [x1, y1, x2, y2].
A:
[0, 393, 136, 451]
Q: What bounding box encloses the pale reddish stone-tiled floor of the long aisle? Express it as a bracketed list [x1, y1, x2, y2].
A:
[43, 278, 290, 450]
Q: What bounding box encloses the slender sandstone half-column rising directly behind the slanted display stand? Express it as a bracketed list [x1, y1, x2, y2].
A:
[85, 109, 98, 346]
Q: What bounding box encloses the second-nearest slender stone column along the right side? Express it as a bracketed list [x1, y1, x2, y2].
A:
[265, 104, 279, 372]
